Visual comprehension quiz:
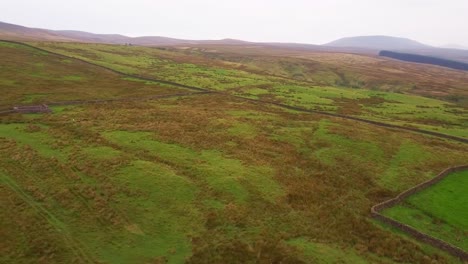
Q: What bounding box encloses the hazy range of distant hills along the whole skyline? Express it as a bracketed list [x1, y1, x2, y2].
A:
[0, 22, 468, 63]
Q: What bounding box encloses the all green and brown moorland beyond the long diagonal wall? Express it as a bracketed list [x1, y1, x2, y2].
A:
[33, 43, 468, 137]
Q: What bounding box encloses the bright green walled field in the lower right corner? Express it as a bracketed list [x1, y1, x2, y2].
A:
[384, 171, 468, 250]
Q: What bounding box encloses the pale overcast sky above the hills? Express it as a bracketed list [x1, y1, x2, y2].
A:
[0, 0, 468, 46]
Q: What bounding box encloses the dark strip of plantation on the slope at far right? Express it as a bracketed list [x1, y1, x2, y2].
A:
[379, 50, 468, 71]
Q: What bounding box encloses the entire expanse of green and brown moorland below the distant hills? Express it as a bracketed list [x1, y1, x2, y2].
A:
[0, 35, 468, 263]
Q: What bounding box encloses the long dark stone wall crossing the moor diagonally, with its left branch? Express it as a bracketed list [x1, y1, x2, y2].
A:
[0, 40, 468, 143]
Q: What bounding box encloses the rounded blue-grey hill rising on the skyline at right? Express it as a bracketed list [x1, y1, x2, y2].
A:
[324, 36, 430, 50]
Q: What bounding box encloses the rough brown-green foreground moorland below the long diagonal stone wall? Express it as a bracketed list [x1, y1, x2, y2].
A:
[0, 94, 468, 263]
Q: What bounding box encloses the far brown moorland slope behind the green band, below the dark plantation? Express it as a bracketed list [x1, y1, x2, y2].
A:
[181, 45, 468, 103]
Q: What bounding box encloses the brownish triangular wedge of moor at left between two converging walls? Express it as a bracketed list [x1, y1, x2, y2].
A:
[0, 42, 186, 107]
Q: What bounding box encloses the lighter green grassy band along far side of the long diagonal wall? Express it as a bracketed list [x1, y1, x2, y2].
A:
[32, 43, 468, 137]
